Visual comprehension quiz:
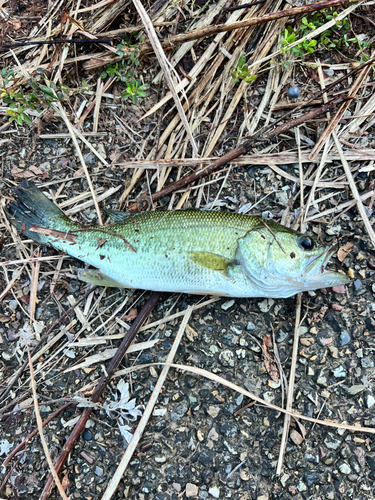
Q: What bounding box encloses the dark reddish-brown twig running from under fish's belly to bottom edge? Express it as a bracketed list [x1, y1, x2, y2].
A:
[39, 292, 161, 500]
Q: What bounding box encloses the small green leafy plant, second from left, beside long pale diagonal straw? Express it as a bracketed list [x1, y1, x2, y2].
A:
[100, 36, 147, 104]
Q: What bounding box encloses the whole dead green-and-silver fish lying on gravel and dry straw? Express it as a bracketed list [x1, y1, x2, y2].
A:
[6, 180, 349, 298]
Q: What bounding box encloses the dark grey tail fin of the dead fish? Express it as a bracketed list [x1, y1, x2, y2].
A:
[5, 179, 69, 244]
